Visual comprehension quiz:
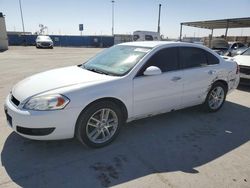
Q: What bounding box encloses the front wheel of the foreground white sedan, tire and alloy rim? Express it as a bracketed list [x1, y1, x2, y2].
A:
[75, 101, 124, 148]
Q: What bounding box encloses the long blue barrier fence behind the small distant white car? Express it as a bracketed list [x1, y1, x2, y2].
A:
[8, 34, 114, 47]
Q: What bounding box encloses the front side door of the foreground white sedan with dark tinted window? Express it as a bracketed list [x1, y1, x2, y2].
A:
[133, 47, 183, 117]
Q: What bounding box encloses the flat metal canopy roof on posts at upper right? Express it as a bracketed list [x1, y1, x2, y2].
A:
[181, 17, 250, 29]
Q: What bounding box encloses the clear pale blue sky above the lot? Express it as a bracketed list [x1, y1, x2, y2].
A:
[0, 0, 250, 38]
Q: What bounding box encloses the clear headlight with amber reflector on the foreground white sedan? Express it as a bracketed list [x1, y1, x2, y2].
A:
[23, 94, 69, 110]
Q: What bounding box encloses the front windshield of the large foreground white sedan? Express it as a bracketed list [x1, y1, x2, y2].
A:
[82, 45, 151, 76]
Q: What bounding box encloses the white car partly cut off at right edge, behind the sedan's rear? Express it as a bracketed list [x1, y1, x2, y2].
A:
[234, 48, 250, 85]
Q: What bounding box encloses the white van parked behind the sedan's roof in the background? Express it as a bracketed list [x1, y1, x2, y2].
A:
[133, 31, 161, 41]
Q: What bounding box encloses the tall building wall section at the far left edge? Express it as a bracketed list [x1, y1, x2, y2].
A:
[0, 12, 8, 51]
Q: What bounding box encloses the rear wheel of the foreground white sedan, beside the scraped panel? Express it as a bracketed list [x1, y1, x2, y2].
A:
[203, 82, 227, 112]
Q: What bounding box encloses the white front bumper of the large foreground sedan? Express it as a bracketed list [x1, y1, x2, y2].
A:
[4, 96, 79, 140]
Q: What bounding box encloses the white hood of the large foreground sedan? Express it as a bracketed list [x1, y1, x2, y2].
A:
[12, 66, 116, 101]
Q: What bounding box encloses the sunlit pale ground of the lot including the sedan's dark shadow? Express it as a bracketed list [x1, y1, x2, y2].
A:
[0, 47, 250, 188]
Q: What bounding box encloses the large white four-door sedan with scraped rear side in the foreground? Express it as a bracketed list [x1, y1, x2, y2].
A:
[5, 41, 239, 147]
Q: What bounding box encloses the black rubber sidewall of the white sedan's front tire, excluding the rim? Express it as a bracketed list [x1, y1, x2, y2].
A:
[75, 101, 123, 148]
